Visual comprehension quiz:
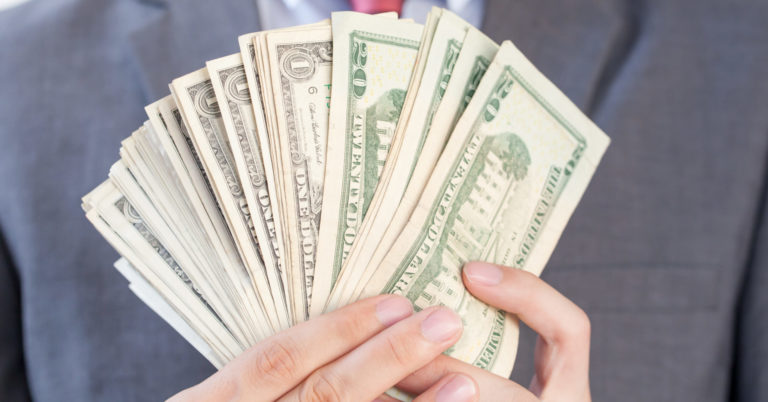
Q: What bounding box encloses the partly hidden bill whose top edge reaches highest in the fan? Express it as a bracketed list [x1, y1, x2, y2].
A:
[328, 10, 475, 309]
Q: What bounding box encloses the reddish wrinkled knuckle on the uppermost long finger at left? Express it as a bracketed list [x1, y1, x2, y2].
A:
[247, 338, 300, 381]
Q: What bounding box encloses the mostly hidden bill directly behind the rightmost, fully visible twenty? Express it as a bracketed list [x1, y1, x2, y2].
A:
[344, 28, 499, 303]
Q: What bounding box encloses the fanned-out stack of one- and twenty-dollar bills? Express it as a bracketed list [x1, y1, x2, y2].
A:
[83, 8, 609, 376]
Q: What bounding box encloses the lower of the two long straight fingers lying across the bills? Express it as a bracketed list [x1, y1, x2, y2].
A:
[281, 307, 462, 401]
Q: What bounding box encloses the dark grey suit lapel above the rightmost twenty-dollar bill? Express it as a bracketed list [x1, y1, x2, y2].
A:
[483, 0, 637, 113]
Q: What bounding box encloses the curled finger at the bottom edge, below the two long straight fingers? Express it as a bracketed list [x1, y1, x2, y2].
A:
[397, 355, 538, 402]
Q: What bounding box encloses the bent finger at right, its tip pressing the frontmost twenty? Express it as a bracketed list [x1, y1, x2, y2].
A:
[462, 262, 590, 400]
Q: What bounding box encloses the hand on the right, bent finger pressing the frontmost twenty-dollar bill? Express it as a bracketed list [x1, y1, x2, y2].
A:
[381, 262, 591, 402]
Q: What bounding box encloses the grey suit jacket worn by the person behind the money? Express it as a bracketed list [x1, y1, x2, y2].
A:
[0, 0, 768, 401]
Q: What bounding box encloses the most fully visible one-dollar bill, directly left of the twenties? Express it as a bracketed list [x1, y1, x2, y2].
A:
[266, 26, 334, 321]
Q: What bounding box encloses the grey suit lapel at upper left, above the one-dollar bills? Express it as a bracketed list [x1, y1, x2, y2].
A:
[130, 0, 259, 101]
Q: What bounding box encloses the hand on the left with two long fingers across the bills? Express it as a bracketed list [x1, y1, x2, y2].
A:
[170, 295, 462, 401]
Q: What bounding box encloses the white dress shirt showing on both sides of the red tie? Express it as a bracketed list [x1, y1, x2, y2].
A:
[256, 0, 485, 30]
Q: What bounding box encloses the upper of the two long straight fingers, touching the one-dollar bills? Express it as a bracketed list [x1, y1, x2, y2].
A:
[170, 295, 413, 400]
